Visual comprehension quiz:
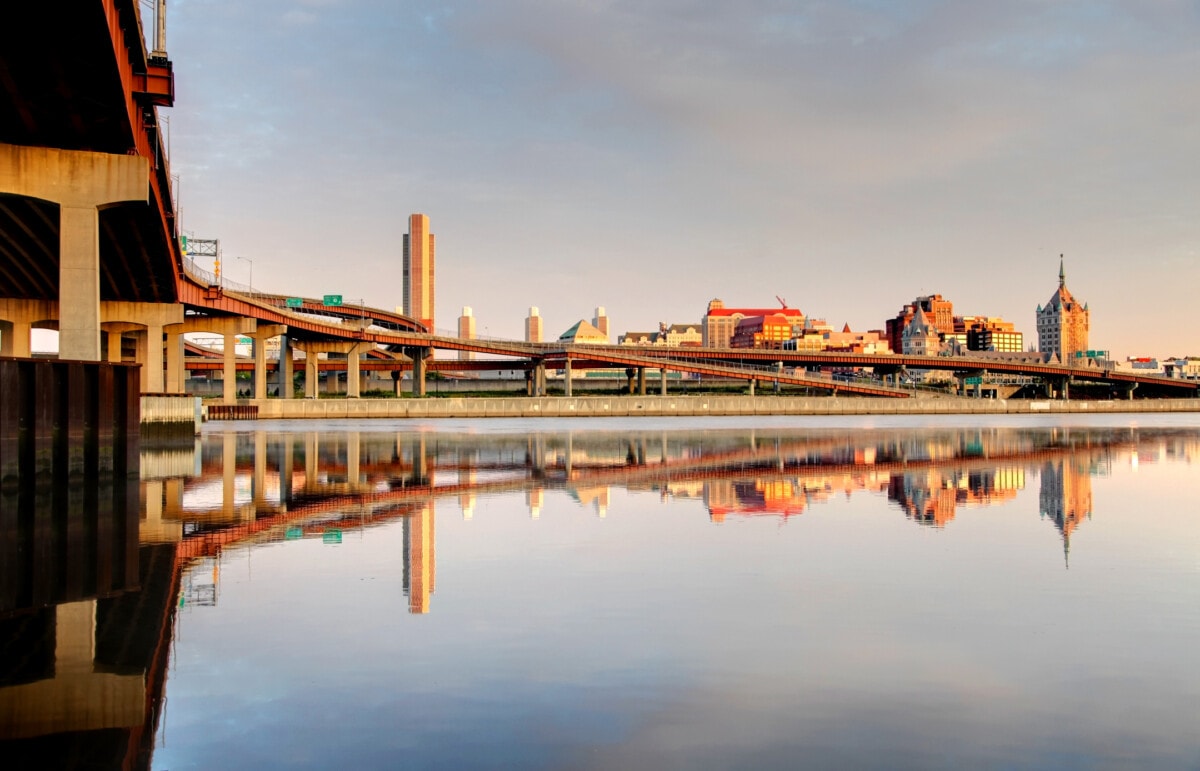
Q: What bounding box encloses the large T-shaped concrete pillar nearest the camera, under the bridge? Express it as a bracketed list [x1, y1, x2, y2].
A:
[0, 144, 150, 361]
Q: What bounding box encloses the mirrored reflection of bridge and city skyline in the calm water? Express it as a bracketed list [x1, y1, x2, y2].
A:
[0, 429, 1200, 767]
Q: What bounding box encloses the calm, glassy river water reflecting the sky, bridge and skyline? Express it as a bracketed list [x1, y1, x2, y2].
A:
[0, 416, 1200, 771]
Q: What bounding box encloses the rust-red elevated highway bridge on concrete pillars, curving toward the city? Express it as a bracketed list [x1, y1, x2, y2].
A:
[0, 0, 1198, 402]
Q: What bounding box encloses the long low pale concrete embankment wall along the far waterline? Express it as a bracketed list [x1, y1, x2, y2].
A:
[211, 395, 1200, 419]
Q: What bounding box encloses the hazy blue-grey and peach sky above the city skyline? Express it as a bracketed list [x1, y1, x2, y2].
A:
[163, 0, 1200, 357]
